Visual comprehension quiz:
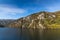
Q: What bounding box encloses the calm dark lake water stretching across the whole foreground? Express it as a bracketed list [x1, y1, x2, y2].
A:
[0, 28, 60, 40]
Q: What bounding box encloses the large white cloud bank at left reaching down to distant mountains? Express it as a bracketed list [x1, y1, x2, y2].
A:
[0, 5, 26, 19]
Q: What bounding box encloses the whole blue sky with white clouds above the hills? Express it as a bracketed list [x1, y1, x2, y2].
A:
[0, 0, 60, 19]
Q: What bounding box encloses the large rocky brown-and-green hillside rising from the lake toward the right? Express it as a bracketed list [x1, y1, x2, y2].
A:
[8, 11, 60, 29]
